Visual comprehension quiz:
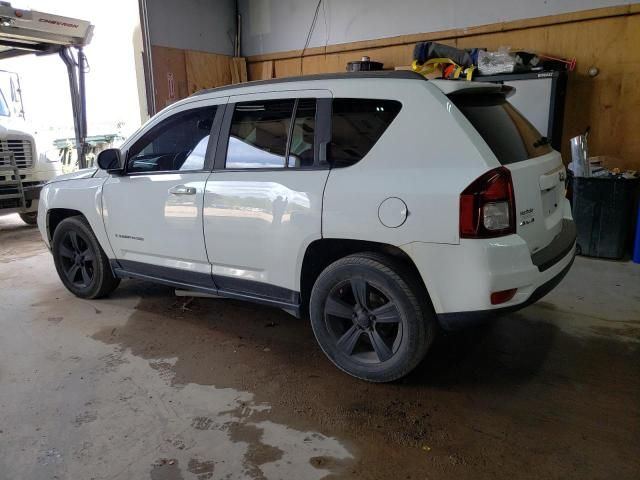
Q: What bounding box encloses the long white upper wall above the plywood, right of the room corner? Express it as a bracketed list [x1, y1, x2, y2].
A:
[239, 0, 633, 56]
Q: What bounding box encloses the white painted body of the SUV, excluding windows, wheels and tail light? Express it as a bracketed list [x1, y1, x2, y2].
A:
[38, 74, 575, 328]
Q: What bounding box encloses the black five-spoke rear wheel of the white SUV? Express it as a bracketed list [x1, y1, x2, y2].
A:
[309, 253, 436, 382]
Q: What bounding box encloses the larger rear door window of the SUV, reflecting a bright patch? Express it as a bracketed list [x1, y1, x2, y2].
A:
[225, 99, 295, 168]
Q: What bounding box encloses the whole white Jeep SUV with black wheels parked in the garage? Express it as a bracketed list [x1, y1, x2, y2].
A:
[38, 72, 575, 382]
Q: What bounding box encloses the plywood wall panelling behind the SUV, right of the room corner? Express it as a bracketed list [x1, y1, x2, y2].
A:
[248, 4, 640, 170]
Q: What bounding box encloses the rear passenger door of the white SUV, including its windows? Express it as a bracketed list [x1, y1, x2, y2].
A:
[204, 90, 331, 305]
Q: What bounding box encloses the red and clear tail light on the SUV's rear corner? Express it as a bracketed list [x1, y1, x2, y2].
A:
[460, 167, 516, 238]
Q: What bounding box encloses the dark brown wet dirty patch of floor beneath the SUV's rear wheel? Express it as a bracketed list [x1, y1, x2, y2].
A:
[93, 284, 640, 479]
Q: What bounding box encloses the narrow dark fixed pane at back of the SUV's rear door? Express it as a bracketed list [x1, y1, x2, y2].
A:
[287, 98, 316, 168]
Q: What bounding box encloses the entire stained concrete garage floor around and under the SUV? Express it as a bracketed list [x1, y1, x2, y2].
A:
[0, 216, 640, 480]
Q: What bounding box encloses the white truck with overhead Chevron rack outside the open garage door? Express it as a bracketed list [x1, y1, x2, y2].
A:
[0, 1, 93, 225]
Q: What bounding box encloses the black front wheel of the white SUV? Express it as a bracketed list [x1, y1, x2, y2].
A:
[51, 217, 120, 298]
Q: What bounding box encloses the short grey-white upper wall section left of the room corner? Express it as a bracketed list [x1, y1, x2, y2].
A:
[146, 0, 236, 55]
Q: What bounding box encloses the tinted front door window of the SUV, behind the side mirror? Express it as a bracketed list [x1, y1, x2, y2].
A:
[127, 107, 216, 172]
